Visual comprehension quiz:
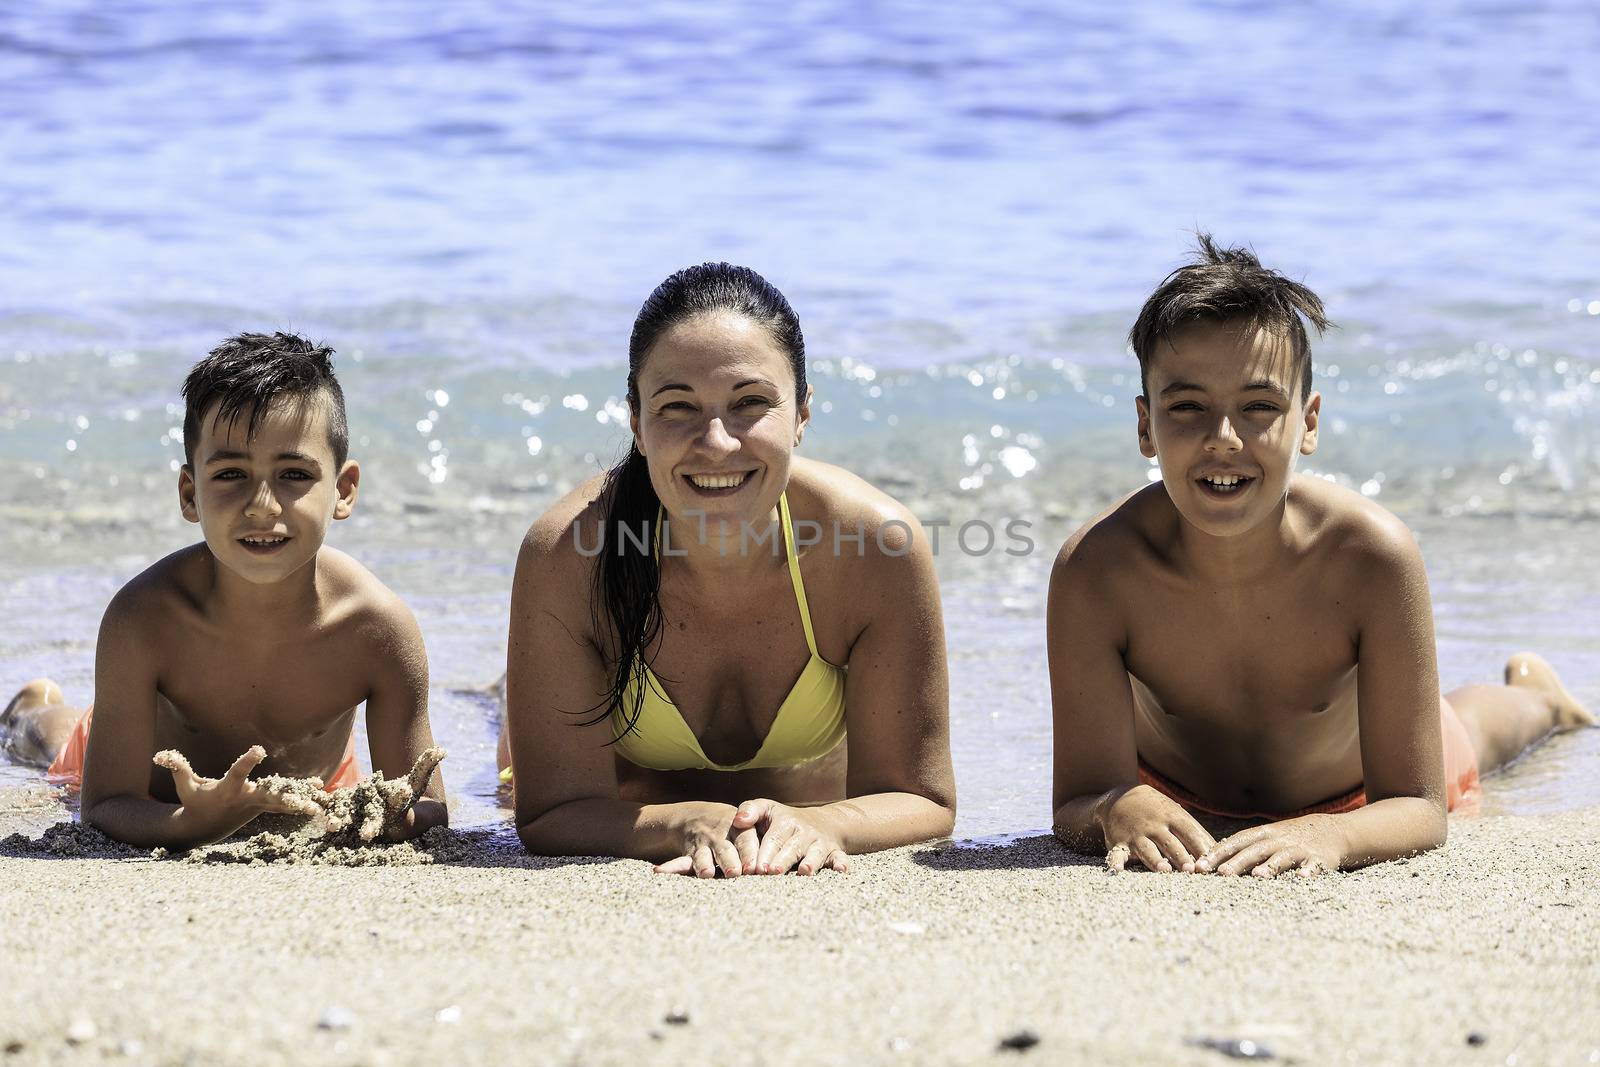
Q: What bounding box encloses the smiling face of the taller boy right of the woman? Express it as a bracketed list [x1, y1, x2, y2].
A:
[1136, 322, 1322, 537]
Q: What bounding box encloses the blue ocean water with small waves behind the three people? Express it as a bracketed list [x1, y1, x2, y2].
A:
[0, 0, 1600, 833]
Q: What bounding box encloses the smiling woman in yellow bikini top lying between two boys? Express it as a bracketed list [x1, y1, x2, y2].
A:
[499, 264, 955, 878]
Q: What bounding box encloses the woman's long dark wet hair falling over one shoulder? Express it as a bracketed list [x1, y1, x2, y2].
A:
[586, 262, 806, 736]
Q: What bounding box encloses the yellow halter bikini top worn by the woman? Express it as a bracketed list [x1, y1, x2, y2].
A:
[611, 493, 845, 771]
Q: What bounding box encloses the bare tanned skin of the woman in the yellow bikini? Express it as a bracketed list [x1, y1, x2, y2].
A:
[502, 314, 955, 878]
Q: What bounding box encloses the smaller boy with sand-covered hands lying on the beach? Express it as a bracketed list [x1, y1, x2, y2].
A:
[8, 333, 448, 846]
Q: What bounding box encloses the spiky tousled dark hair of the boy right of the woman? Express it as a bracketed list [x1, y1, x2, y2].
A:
[1128, 234, 1333, 403]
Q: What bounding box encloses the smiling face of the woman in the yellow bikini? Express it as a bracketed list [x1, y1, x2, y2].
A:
[634, 310, 811, 533]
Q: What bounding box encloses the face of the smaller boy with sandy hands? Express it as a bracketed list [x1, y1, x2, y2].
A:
[178, 395, 360, 585]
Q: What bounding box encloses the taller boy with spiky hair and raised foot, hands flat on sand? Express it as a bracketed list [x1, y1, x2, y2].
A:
[1048, 237, 1594, 877]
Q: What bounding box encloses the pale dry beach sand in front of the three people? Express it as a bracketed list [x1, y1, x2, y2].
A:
[0, 789, 1600, 1067]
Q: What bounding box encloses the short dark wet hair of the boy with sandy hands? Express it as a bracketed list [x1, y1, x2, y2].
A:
[184, 333, 350, 467]
